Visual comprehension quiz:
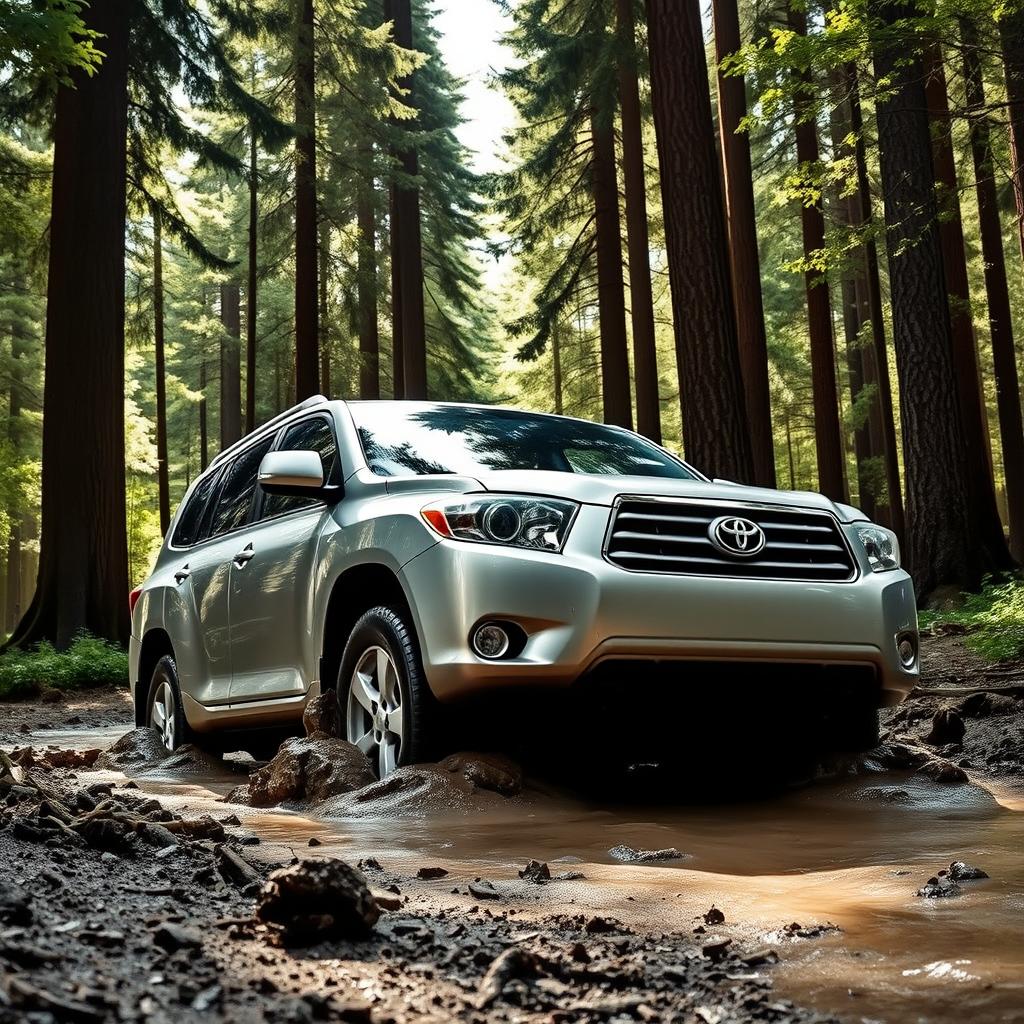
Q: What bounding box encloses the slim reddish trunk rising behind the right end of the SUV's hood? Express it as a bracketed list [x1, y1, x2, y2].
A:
[787, 6, 846, 502]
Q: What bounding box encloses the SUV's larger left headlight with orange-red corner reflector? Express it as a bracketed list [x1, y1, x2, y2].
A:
[420, 495, 579, 551]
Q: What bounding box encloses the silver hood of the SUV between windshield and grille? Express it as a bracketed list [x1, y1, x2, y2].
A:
[464, 470, 864, 522]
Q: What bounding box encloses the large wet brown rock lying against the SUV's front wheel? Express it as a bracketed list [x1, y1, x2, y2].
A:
[249, 735, 376, 807]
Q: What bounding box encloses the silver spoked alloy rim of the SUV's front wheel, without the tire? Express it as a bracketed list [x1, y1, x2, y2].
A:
[345, 647, 404, 778]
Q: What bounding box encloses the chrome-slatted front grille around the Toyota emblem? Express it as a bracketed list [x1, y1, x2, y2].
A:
[605, 498, 857, 583]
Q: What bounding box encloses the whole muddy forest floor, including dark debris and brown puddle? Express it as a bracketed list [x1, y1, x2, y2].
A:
[0, 635, 1024, 1024]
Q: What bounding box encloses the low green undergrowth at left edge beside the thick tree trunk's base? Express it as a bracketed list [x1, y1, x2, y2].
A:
[0, 634, 128, 700]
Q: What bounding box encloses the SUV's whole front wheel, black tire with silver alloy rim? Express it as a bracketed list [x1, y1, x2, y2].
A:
[337, 605, 434, 778]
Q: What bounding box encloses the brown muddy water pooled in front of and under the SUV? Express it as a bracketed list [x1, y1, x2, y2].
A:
[32, 729, 1024, 1024]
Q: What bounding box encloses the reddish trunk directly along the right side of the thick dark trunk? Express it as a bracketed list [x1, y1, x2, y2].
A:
[924, 43, 1006, 551]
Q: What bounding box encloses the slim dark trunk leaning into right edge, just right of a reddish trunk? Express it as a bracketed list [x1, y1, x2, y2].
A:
[961, 18, 1024, 562]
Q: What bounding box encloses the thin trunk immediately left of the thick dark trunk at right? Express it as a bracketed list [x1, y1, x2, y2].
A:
[844, 65, 906, 538]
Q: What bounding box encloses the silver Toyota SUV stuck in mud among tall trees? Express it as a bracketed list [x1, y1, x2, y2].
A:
[130, 397, 918, 776]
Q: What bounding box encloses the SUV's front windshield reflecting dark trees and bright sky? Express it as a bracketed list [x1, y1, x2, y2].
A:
[349, 401, 694, 480]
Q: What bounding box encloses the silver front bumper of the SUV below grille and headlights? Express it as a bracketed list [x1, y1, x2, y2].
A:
[402, 505, 918, 705]
